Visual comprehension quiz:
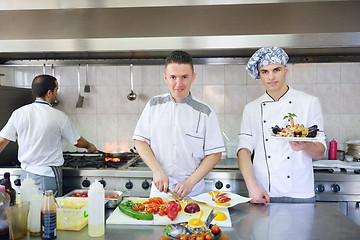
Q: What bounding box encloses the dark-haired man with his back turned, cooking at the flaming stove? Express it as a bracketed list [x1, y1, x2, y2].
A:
[0, 75, 96, 196]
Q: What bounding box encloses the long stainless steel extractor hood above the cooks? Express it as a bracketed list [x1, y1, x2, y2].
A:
[0, 0, 360, 64]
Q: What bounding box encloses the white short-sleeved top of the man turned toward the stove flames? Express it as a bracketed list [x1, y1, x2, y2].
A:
[0, 101, 80, 177]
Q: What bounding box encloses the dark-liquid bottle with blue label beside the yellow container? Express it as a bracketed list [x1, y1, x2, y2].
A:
[41, 190, 56, 239]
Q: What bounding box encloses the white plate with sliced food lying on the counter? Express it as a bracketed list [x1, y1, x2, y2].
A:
[192, 191, 251, 208]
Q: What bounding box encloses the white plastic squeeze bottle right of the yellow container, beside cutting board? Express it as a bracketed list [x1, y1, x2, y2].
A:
[88, 180, 105, 237]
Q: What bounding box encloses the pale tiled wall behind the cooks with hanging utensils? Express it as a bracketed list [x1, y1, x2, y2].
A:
[0, 63, 360, 158]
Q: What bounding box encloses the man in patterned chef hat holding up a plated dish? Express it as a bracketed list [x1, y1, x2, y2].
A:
[237, 47, 326, 203]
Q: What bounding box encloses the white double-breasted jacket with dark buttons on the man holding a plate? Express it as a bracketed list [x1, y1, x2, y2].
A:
[238, 88, 326, 198]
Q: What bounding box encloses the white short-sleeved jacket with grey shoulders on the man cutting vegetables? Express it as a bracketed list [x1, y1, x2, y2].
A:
[133, 93, 225, 196]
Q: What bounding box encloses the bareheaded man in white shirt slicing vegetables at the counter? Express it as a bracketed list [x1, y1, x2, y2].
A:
[133, 51, 225, 198]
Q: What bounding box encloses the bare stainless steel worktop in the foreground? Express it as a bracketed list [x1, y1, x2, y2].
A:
[19, 203, 360, 240]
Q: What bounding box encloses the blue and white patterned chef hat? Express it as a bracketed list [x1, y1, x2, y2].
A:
[246, 47, 289, 80]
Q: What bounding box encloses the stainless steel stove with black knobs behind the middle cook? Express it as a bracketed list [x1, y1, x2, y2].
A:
[63, 152, 247, 197]
